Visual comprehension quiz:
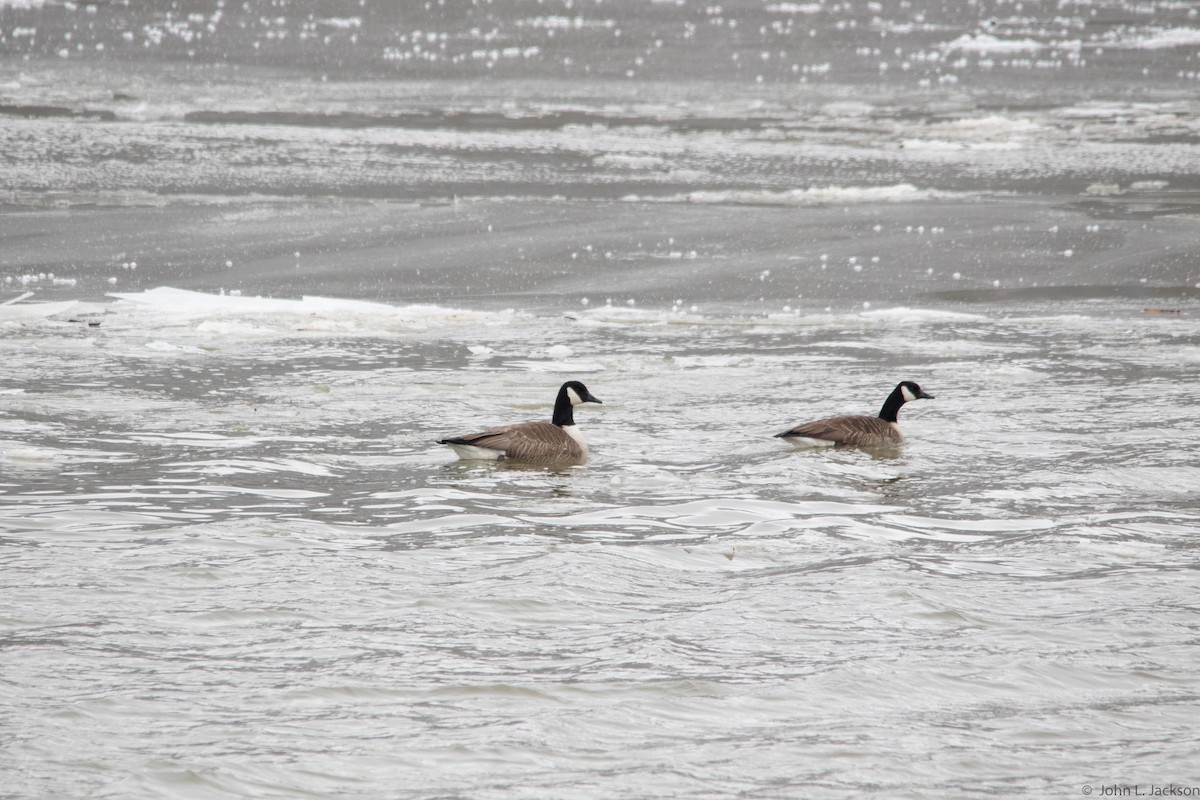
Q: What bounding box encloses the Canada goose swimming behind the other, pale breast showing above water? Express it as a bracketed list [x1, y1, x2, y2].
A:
[438, 380, 600, 464]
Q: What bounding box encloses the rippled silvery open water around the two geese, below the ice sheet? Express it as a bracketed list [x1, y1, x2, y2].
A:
[7, 293, 1200, 796]
